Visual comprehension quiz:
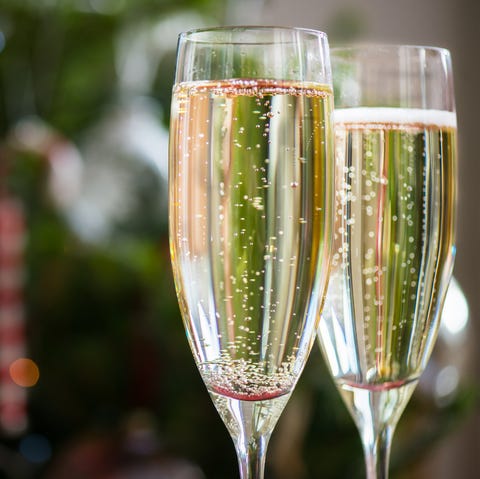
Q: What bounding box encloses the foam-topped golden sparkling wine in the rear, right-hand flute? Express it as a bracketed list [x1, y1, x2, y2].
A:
[318, 108, 456, 400]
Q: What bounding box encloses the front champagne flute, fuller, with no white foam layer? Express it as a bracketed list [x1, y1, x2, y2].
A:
[169, 27, 334, 479]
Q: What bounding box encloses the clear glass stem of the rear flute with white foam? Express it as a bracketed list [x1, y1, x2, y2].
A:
[362, 425, 394, 479]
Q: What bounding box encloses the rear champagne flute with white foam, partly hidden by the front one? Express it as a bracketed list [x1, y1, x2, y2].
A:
[318, 45, 456, 479]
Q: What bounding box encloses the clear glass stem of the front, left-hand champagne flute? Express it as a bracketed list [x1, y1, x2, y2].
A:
[235, 434, 270, 479]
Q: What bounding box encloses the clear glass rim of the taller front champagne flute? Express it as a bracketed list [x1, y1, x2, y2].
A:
[178, 25, 328, 45]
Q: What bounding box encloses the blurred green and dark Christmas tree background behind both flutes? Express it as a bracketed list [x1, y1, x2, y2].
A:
[0, 0, 480, 479]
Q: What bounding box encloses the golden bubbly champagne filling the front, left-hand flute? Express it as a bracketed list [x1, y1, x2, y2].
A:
[170, 80, 333, 400]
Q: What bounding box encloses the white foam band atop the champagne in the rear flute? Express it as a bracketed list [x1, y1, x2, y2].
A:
[334, 107, 457, 128]
